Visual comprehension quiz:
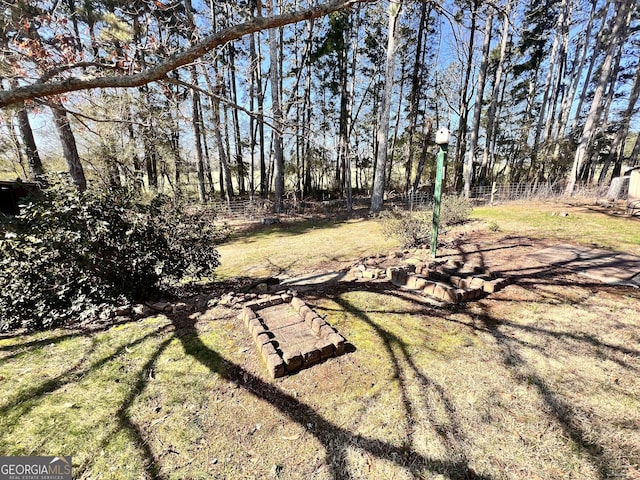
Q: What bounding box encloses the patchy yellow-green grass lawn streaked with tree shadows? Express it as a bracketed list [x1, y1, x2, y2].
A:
[0, 204, 640, 480]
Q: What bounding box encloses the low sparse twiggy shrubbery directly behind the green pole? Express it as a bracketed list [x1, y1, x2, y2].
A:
[380, 195, 473, 248]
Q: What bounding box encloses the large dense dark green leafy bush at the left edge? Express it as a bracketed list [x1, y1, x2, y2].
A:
[0, 185, 225, 330]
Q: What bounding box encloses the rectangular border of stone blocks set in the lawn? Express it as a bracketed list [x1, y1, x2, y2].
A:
[238, 293, 345, 378]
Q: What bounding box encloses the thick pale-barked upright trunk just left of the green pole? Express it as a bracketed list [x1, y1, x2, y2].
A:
[371, 0, 402, 213]
